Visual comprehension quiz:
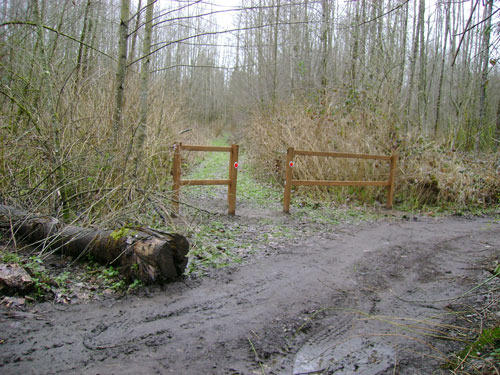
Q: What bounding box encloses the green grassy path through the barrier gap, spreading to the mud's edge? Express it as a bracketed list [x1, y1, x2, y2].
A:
[176, 139, 381, 275]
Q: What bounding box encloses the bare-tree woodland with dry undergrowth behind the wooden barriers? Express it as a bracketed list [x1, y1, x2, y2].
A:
[0, 0, 500, 224]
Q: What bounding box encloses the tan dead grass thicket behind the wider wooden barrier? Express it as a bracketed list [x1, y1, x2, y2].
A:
[246, 93, 500, 208]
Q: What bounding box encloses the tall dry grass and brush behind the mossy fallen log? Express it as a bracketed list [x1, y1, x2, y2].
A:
[0, 72, 209, 225]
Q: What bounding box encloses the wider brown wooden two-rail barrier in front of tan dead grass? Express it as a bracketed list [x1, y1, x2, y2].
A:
[283, 147, 398, 213]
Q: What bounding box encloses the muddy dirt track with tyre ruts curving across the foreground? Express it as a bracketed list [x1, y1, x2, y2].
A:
[0, 214, 500, 375]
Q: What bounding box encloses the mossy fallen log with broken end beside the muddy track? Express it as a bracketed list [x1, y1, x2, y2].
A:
[0, 205, 189, 284]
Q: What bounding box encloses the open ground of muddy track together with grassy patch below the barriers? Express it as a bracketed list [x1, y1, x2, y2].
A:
[0, 145, 500, 375]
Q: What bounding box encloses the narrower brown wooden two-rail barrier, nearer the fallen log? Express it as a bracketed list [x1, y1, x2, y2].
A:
[172, 143, 239, 215]
